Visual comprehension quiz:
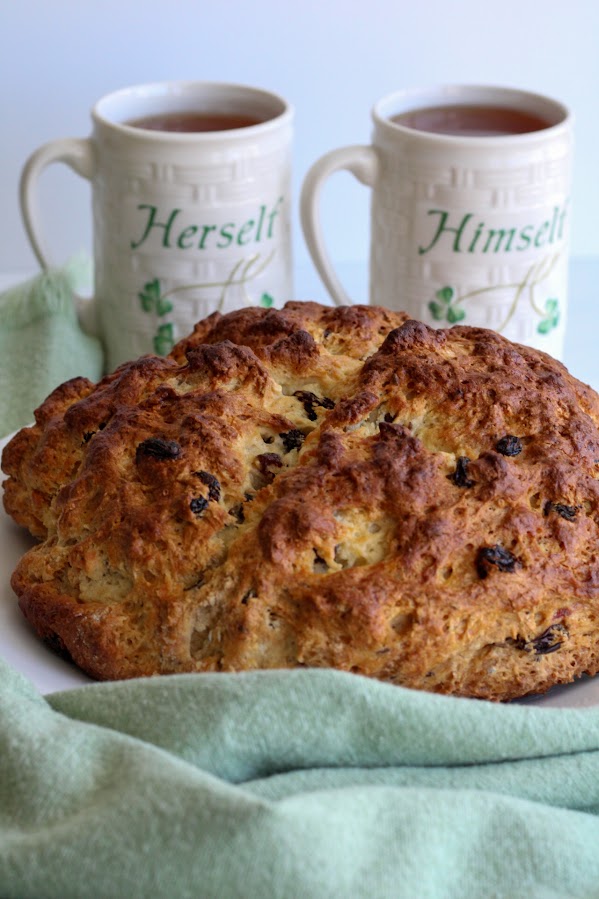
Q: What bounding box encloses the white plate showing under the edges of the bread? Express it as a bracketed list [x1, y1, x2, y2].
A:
[0, 435, 599, 708]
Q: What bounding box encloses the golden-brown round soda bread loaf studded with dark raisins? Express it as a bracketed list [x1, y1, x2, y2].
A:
[3, 303, 599, 700]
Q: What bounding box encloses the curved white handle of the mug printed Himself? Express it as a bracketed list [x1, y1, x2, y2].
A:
[300, 144, 378, 306]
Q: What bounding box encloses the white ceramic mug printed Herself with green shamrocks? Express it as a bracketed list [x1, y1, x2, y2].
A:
[21, 82, 293, 370]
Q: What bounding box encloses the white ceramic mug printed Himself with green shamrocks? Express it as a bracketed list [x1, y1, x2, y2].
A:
[301, 86, 572, 358]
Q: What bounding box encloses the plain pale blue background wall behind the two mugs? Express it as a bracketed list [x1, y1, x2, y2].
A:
[0, 0, 599, 300]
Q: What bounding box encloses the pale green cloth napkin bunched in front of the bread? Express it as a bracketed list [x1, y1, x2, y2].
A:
[0, 662, 599, 899]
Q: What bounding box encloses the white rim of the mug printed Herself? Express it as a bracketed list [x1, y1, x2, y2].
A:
[91, 79, 294, 143]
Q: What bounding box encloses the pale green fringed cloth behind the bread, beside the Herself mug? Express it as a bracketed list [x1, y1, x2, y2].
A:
[0, 261, 103, 437]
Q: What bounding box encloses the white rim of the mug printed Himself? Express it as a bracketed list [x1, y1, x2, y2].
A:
[372, 83, 572, 147]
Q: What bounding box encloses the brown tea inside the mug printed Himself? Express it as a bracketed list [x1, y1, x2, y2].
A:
[390, 104, 552, 137]
